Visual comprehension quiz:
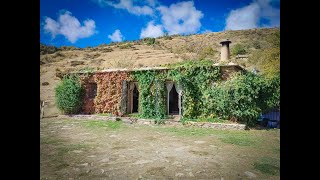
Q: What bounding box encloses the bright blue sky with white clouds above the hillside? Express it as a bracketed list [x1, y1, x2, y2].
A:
[40, 0, 280, 47]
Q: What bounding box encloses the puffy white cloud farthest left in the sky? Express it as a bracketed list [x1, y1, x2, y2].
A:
[44, 11, 96, 43]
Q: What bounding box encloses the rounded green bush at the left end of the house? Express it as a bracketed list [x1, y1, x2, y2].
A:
[55, 75, 84, 114]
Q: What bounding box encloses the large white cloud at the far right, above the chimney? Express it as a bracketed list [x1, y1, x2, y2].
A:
[225, 0, 280, 30]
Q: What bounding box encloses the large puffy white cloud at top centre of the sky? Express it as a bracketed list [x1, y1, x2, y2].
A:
[157, 1, 203, 34]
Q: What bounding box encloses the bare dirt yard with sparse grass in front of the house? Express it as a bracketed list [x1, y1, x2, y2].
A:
[40, 118, 280, 180]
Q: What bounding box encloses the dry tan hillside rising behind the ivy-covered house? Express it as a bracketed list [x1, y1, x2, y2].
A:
[40, 28, 280, 116]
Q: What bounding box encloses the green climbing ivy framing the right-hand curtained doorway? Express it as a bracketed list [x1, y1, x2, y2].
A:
[132, 59, 221, 119]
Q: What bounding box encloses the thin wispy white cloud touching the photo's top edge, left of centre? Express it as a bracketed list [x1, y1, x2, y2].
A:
[96, 0, 156, 15]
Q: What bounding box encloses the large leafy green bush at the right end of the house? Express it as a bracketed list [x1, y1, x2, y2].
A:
[205, 73, 280, 126]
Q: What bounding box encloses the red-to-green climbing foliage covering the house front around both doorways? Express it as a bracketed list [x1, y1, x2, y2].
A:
[75, 61, 280, 124]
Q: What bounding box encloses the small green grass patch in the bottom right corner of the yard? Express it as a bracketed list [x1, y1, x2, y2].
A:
[253, 157, 280, 175]
